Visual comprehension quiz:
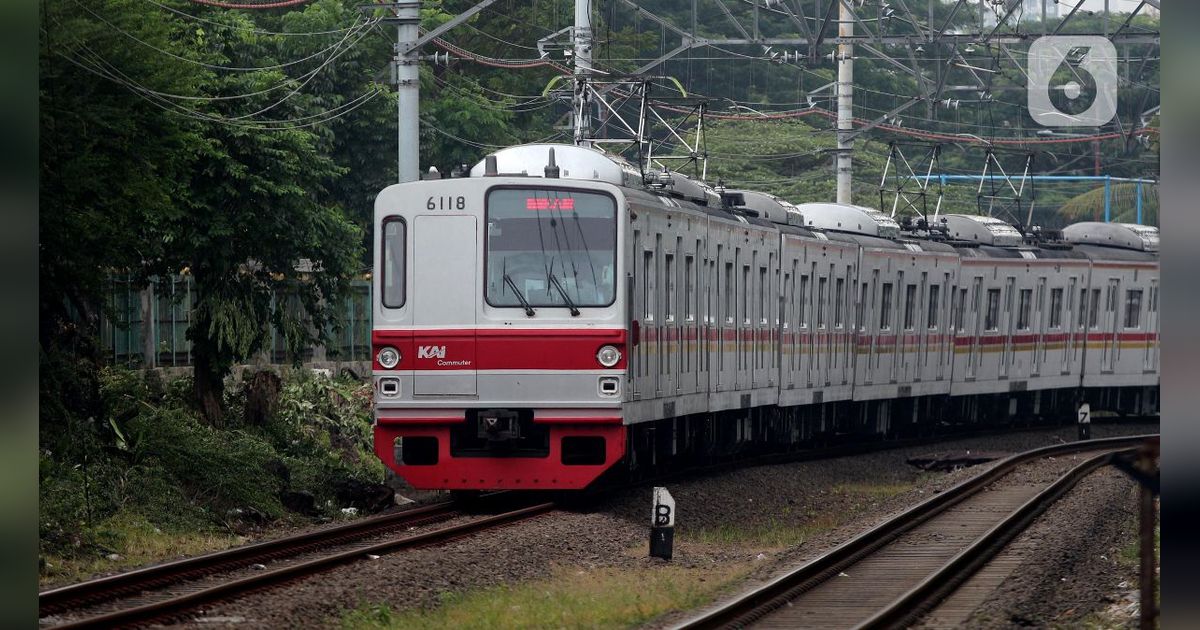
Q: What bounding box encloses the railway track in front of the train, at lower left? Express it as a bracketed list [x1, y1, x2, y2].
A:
[38, 493, 554, 629]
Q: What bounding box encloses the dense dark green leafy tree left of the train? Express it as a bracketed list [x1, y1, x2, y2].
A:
[41, 0, 361, 424]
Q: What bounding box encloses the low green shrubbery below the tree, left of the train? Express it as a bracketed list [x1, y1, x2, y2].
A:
[40, 356, 384, 580]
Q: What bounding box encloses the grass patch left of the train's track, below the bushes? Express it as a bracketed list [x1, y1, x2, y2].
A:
[38, 512, 245, 588]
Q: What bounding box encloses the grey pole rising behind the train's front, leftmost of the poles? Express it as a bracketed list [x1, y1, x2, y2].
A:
[395, 1, 421, 184]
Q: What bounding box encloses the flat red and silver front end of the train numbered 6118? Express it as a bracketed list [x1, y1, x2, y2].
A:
[372, 146, 628, 491]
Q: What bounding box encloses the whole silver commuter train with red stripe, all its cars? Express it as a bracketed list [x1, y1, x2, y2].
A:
[372, 144, 1159, 491]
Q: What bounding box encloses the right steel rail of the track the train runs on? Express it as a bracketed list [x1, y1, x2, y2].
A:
[44, 503, 554, 630]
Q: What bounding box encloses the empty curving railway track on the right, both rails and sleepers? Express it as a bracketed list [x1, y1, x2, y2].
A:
[678, 436, 1157, 630]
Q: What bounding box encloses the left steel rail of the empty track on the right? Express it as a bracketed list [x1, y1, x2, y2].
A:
[674, 436, 1153, 630]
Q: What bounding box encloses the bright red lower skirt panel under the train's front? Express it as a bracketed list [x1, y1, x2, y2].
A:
[374, 413, 625, 490]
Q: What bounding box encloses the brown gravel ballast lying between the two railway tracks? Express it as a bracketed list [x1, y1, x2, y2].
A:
[169, 424, 1158, 628]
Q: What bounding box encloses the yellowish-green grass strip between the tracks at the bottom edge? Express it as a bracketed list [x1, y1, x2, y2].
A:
[341, 564, 750, 630]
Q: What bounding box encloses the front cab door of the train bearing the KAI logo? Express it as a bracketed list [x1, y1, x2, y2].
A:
[413, 215, 480, 396]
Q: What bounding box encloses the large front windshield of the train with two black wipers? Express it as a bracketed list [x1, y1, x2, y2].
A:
[486, 188, 617, 311]
